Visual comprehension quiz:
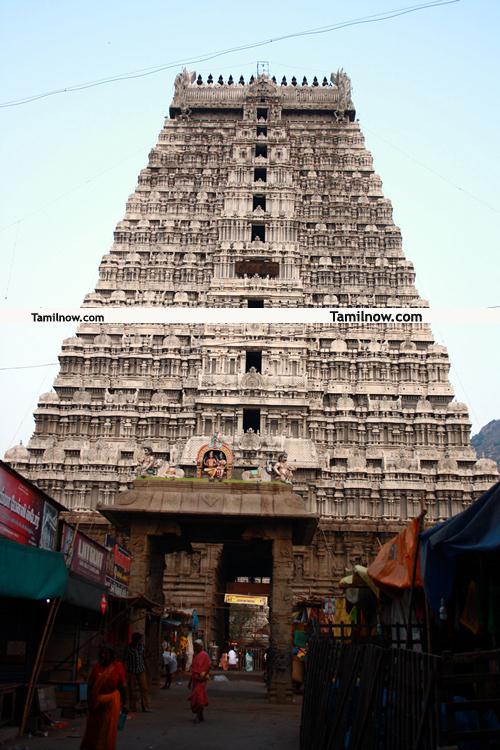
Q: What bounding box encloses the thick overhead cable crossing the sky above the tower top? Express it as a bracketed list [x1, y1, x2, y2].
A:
[0, 0, 460, 108]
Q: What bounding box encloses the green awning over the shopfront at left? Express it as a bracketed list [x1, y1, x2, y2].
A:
[0, 537, 68, 599]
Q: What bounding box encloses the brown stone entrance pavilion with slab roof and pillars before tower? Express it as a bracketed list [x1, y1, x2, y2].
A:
[100, 478, 318, 703]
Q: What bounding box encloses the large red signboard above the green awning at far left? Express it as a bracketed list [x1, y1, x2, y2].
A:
[0, 466, 44, 547]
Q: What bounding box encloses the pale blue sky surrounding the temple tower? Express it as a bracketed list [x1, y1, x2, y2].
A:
[0, 0, 500, 455]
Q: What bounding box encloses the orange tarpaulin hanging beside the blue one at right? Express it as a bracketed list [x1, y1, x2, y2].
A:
[368, 517, 423, 589]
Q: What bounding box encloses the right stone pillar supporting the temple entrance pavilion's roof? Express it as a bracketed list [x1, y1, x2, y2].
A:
[268, 524, 293, 703]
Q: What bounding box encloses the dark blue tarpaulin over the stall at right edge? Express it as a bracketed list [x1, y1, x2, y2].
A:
[420, 482, 500, 613]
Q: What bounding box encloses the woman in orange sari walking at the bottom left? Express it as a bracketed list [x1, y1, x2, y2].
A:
[80, 646, 125, 750]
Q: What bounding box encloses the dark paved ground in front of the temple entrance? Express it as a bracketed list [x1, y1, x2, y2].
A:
[5, 677, 301, 750]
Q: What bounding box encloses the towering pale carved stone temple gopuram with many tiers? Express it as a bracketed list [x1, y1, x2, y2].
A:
[6, 71, 498, 611]
